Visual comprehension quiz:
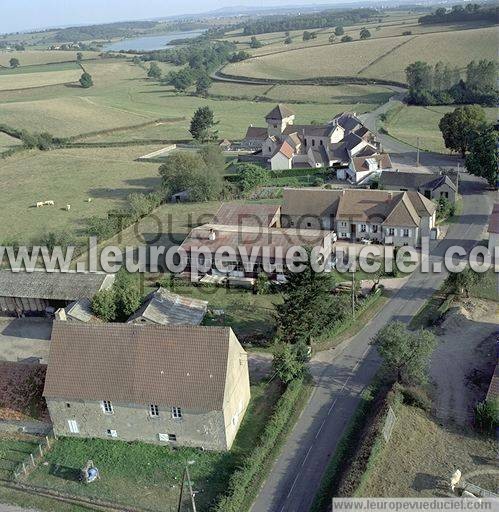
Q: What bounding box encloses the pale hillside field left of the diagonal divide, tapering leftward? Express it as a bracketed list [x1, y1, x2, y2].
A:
[224, 37, 405, 80]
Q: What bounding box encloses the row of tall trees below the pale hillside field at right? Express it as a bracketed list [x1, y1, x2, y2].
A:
[405, 60, 497, 106]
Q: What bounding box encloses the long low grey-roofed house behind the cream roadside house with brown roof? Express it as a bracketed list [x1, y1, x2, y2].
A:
[379, 170, 457, 203]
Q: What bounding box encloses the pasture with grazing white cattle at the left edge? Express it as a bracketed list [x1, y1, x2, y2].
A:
[0, 145, 160, 241]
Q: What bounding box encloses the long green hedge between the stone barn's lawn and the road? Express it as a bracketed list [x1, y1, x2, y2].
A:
[211, 378, 309, 512]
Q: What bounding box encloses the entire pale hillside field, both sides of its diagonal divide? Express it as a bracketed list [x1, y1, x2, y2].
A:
[224, 27, 497, 81]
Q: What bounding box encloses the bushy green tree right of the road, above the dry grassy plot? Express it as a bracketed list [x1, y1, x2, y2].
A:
[372, 322, 437, 384]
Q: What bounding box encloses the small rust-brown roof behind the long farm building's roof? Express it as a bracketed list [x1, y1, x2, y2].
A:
[213, 203, 281, 227]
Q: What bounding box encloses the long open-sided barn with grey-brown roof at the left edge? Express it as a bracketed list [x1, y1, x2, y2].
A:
[0, 270, 114, 316]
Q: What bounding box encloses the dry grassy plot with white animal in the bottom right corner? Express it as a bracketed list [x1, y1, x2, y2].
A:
[362, 405, 497, 498]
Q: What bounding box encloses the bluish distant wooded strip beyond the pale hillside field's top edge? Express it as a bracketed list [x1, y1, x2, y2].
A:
[243, 9, 379, 35]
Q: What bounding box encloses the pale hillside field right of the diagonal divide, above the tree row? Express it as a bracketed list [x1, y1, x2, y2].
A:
[361, 27, 497, 81]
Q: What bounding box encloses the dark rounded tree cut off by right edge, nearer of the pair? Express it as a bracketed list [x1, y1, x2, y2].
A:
[466, 126, 499, 188]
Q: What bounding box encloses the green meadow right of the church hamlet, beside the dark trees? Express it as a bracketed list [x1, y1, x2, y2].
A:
[386, 106, 497, 153]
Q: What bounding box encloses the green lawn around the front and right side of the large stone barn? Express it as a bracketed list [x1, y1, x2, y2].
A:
[28, 383, 280, 512]
